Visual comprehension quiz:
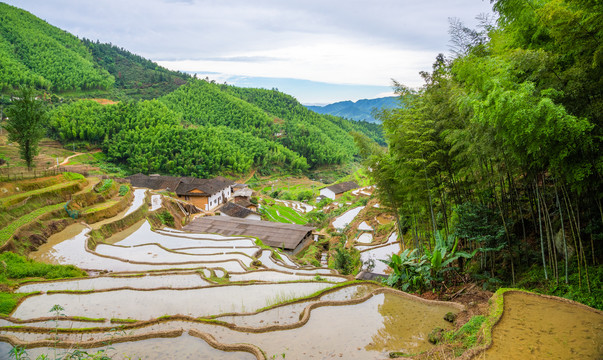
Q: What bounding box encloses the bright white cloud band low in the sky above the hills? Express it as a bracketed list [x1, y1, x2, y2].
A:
[159, 35, 437, 86]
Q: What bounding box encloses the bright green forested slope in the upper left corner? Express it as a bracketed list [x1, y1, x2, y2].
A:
[0, 3, 114, 91]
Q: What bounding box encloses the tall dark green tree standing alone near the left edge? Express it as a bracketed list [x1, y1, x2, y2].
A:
[5, 87, 46, 170]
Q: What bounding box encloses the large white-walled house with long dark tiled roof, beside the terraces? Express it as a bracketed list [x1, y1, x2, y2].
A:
[128, 174, 234, 211]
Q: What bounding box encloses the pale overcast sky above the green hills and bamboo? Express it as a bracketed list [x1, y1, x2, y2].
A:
[5, 0, 491, 103]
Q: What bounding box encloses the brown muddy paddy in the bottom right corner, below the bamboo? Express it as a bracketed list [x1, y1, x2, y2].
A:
[484, 292, 603, 359]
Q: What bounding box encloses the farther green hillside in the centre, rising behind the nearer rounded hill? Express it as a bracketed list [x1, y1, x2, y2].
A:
[161, 81, 383, 166]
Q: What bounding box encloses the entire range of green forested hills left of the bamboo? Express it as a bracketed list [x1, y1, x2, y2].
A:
[0, 4, 385, 177]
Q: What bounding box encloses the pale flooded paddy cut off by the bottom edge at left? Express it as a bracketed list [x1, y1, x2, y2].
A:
[21, 333, 256, 360]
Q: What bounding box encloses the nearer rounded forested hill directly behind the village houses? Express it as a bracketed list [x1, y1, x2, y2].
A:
[50, 100, 308, 177]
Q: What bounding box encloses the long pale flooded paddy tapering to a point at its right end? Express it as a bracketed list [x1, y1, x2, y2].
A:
[12, 283, 332, 320]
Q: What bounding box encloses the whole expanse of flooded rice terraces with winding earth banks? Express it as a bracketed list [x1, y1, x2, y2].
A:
[0, 205, 460, 359]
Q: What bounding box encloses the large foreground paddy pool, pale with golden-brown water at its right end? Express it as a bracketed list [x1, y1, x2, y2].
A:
[213, 294, 457, 360]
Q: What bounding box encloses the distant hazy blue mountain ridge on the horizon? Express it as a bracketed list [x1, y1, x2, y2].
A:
[306, 96, 399, 123]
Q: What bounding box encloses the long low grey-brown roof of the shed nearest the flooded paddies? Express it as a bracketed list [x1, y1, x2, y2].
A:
[183, 216, 314, 250]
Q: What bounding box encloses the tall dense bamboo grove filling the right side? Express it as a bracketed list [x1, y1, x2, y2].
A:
[356, 0, 603, 307]
